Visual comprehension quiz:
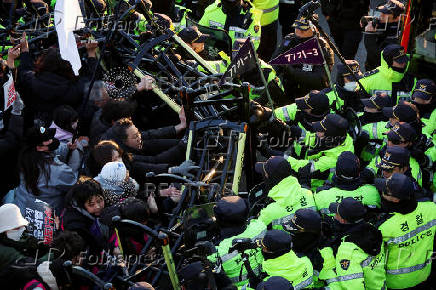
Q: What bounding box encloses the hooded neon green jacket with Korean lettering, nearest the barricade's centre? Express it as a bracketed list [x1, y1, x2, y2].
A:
[258, 176, 316, 230]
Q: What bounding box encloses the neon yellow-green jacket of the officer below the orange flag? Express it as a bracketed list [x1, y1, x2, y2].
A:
[359, 54, 416, 104]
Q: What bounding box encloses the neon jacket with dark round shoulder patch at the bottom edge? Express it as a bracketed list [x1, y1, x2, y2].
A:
[326, 242, 386, 290]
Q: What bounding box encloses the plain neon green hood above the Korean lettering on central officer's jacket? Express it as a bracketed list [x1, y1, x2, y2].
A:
[268, 176, 306, 206]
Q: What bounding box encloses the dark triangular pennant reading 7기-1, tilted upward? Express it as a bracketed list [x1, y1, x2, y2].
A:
[219, 38, 256, 85]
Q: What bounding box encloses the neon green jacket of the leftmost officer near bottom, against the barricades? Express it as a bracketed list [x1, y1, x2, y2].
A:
[208, 220, 266, 286]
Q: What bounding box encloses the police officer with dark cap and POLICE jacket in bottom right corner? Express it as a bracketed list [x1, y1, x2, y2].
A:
[375, 173, 436, 289]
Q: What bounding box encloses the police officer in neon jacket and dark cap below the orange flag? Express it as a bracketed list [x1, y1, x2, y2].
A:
[360, 44, 416, 104]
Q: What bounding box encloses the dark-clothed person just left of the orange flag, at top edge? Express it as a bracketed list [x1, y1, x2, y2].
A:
[361, 0, 405, 71]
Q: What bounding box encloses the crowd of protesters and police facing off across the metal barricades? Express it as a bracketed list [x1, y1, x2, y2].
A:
[0, 0, 436, 290]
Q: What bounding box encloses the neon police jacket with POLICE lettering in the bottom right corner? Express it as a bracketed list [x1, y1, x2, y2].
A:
[379, 202, 436, 289]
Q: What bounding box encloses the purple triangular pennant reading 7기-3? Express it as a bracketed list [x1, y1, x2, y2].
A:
[269, 37, 324, 65]
